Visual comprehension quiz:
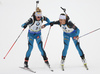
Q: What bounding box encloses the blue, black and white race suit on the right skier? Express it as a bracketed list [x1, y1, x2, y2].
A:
[45, 20, 84, 57]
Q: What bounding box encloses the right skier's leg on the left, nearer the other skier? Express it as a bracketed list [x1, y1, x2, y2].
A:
[61, 33, 70, 70]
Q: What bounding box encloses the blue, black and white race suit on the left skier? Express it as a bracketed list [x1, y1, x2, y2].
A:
[22, 15, 50, 60]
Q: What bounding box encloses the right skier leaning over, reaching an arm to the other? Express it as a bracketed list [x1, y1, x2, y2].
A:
[42, 13, 86, 68]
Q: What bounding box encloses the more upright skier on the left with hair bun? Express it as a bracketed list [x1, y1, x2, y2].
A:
[22, 7, 50, 67]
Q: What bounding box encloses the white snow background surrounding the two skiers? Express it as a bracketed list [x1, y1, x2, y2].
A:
[0, 0, 100, 74]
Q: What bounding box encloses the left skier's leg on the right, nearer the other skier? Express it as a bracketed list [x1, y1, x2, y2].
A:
[36, 35, 49, 65]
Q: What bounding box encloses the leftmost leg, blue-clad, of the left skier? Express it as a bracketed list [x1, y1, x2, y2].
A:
[24, 33, 34, 67]
